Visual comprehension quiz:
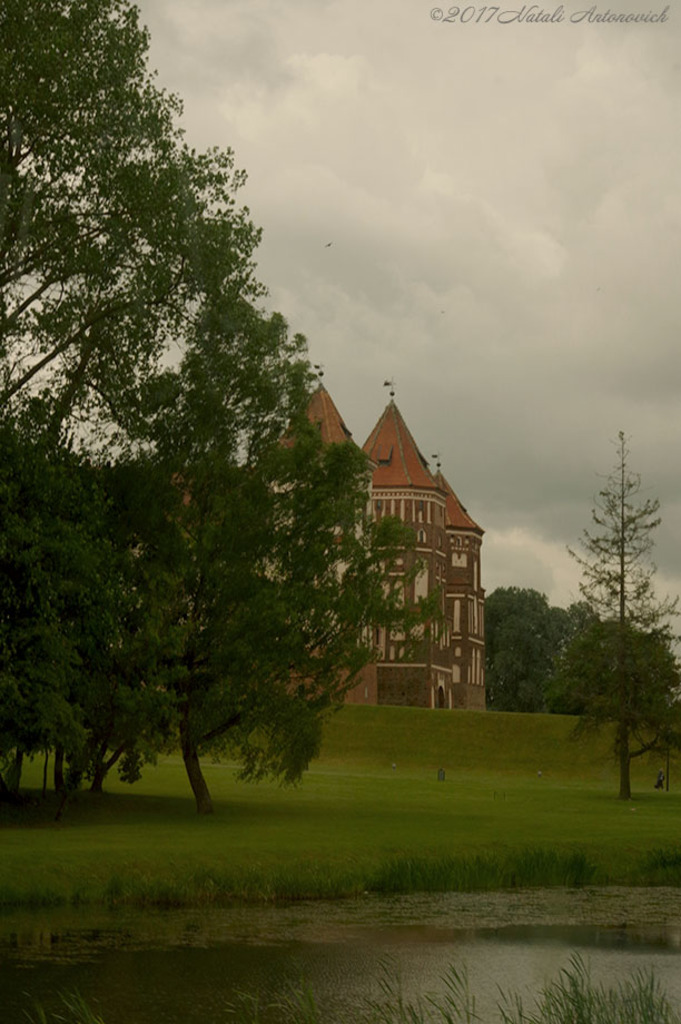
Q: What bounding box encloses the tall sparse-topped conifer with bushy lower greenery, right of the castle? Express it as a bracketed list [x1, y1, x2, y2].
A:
[564, 431, 679, 800]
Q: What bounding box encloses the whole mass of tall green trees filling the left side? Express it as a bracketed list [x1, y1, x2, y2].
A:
[0, 0, 417, 813]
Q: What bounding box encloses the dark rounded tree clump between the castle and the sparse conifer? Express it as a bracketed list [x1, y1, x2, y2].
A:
[485, 587, 584, 712]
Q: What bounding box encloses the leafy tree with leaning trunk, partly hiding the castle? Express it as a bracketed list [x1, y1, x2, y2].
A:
[123, 323, 408, 813]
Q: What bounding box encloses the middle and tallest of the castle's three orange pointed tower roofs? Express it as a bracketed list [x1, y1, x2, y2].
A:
[364, 401, 438, 490]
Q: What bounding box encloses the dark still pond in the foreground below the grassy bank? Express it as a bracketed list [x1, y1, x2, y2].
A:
[0, 889, 681, 1024]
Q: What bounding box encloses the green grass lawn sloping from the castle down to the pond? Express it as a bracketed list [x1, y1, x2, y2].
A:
[0, 707, 681, 906]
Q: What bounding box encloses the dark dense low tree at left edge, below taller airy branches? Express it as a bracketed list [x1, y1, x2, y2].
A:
[0, 424, 163, 793]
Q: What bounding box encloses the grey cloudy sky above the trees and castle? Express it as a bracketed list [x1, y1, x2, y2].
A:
[139, 0, 681, 604]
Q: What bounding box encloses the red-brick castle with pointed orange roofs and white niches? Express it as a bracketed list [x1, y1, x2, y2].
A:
[308, 385, 485, 710]
